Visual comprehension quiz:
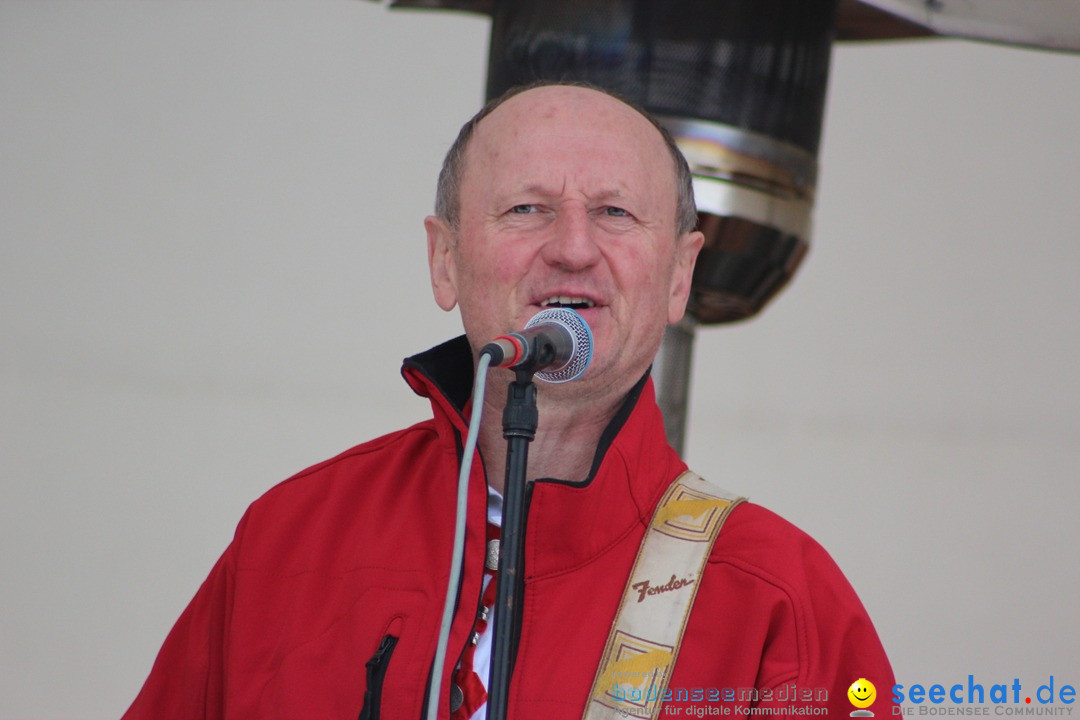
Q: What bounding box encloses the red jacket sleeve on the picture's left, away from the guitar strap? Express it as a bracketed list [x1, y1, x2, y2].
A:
[123, 521, 244, 720]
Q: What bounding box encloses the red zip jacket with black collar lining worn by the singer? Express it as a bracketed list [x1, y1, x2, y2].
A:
[124, 338, 893, 720]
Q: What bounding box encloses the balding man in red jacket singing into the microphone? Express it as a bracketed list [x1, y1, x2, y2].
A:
[126, 85, 893, 719]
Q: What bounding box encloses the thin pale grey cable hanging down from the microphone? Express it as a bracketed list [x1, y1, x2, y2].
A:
[428, 353, 491, 720]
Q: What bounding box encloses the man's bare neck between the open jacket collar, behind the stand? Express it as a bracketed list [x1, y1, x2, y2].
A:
[478, 378, 623, 492]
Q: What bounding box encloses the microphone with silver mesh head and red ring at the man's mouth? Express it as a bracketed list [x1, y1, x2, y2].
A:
[480, 308, 593, 382]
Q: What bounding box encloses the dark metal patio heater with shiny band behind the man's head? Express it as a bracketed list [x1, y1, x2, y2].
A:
[369, 0, 1080, 452]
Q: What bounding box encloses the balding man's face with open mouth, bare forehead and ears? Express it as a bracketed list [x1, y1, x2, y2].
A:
[426, 86, 702, 397]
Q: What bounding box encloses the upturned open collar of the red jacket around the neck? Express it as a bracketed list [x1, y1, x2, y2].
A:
[402, 336, 686, 580]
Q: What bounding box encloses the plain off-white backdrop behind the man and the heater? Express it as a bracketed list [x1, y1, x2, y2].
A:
[0, 0, 1080, 720]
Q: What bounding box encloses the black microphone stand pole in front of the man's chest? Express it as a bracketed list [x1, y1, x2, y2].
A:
[487, 369, 539, 720]
